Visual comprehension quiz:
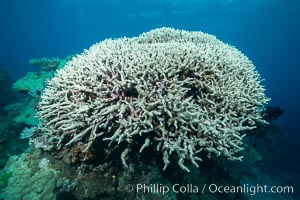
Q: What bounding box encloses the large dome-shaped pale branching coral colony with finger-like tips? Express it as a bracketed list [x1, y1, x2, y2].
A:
[31, 28, 268, 171]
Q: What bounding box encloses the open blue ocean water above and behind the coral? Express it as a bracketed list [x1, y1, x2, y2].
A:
[0, 0, 300, 198]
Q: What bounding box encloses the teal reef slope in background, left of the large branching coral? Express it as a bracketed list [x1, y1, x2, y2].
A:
[0, 56, 72, 167]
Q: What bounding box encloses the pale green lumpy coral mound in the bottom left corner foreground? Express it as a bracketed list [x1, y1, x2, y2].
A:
[0, 151, 59, 200]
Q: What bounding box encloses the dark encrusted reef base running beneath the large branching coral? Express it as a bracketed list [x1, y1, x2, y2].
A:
[0, 146, 248, 200]
